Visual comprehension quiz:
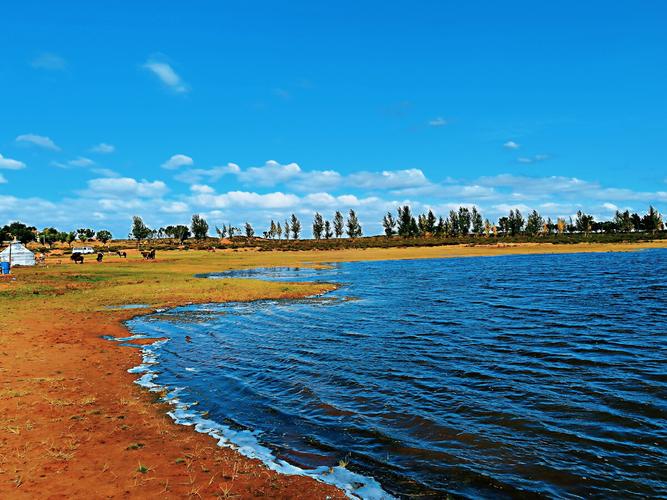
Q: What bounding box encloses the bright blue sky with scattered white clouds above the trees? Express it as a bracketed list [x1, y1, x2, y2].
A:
[0, 0, 667, 236]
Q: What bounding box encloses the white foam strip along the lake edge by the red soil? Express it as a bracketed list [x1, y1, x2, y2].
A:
[114, 336, 393, 500]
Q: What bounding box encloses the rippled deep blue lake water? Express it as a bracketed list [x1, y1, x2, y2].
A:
[124, 250, 667, 498]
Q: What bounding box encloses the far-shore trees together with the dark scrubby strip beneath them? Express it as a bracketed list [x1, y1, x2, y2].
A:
[0, 205, 667, 253]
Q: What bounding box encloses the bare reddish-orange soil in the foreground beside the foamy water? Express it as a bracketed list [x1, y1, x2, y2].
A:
[0, 266, 345, 499]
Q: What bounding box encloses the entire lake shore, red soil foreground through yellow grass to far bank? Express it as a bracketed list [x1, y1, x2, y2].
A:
[0, 242, 667, 498]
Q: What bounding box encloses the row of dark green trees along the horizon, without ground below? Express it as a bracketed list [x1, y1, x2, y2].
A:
[0, 205, 665, 247]
